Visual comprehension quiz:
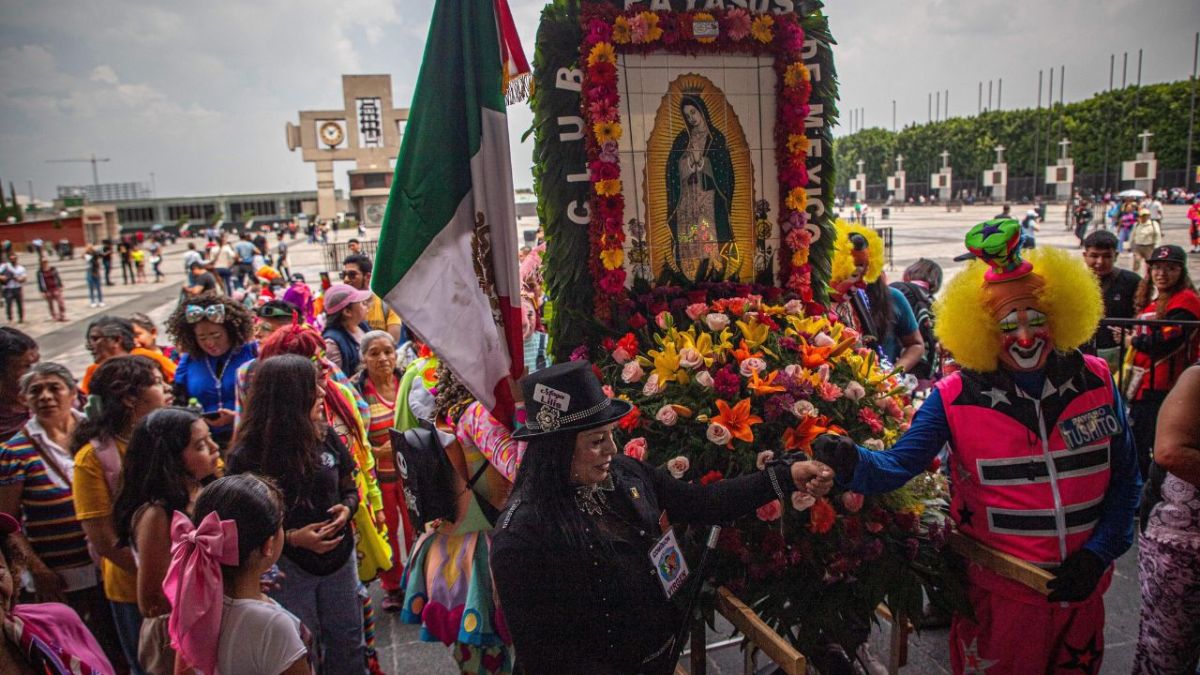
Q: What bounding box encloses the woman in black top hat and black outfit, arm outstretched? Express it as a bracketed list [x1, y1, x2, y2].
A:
[492, 362, 833, 675]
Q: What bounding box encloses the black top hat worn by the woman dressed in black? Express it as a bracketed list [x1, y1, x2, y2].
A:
[512, 360, 634, 440]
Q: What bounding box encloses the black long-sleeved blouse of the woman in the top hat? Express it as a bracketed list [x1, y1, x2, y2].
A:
[491, 455, 796, 675]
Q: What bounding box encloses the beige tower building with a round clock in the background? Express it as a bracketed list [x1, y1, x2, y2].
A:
[287, 74, 408, 226]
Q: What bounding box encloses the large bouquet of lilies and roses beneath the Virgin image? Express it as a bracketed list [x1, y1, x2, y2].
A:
[598, 294, 956, 653]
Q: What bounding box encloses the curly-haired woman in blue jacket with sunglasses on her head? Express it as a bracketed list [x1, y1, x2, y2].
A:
[167, 295, 258, 449]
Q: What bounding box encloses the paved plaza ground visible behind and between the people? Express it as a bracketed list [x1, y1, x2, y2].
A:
[4, 205, 1200, 675]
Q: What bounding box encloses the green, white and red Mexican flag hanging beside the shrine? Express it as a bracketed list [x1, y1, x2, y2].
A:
[371, 0, 528, 424]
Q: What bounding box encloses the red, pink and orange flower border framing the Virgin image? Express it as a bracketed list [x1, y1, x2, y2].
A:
[580, 4, 814, 322]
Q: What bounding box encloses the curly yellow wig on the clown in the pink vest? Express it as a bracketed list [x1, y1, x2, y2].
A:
[936, 246, 1104, 372]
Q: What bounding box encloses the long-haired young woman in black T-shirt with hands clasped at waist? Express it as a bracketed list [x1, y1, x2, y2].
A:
[229, 354, 366, 673]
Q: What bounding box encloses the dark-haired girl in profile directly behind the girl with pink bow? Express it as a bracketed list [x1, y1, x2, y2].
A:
[113, 408, 220, 673]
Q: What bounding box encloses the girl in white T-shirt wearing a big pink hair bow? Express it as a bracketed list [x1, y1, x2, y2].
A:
[163, 473, 312, 675]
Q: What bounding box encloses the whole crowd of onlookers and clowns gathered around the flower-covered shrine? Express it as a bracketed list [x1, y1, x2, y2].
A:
[0, 205, 1200, 674]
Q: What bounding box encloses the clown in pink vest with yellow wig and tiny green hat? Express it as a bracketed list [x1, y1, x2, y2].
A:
[812, 219, 1141, 675]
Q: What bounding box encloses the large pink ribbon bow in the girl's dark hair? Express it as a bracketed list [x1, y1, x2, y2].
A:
[162, 510, 238, 674]
